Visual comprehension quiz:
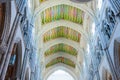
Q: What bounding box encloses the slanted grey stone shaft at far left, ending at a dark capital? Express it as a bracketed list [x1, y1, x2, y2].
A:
[1, 13, 20, 80]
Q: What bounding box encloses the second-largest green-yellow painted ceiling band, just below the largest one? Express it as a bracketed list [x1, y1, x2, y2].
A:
[43, 26, 81, 42]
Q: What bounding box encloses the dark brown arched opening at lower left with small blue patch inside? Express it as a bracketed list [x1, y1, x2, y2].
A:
[5, 40, 22, 79]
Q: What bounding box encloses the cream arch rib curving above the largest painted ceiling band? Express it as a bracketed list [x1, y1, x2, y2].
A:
[34, 0, 94, 18]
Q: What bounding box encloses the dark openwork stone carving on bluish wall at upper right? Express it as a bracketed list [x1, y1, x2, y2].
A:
[101, 8, 116, 40]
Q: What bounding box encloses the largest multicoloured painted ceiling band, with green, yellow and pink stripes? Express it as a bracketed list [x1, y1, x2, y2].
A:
[41, 4, 83, 25]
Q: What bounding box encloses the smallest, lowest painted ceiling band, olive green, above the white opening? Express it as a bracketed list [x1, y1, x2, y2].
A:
[46, 57, 75, 68]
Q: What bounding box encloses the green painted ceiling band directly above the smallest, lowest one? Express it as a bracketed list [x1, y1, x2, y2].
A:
[45, 43, 78, 57]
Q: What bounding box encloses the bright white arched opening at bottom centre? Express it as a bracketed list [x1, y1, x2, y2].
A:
[47, 69, 75, 80]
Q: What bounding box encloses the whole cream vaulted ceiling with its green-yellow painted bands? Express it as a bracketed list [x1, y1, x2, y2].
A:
[34, 0, 94, 79]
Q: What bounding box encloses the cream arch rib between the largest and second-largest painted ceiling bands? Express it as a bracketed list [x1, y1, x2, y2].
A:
[37, 20, 88, 40]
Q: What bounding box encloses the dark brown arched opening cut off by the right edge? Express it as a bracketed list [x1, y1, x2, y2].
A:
[114, 38, 120, 76]
